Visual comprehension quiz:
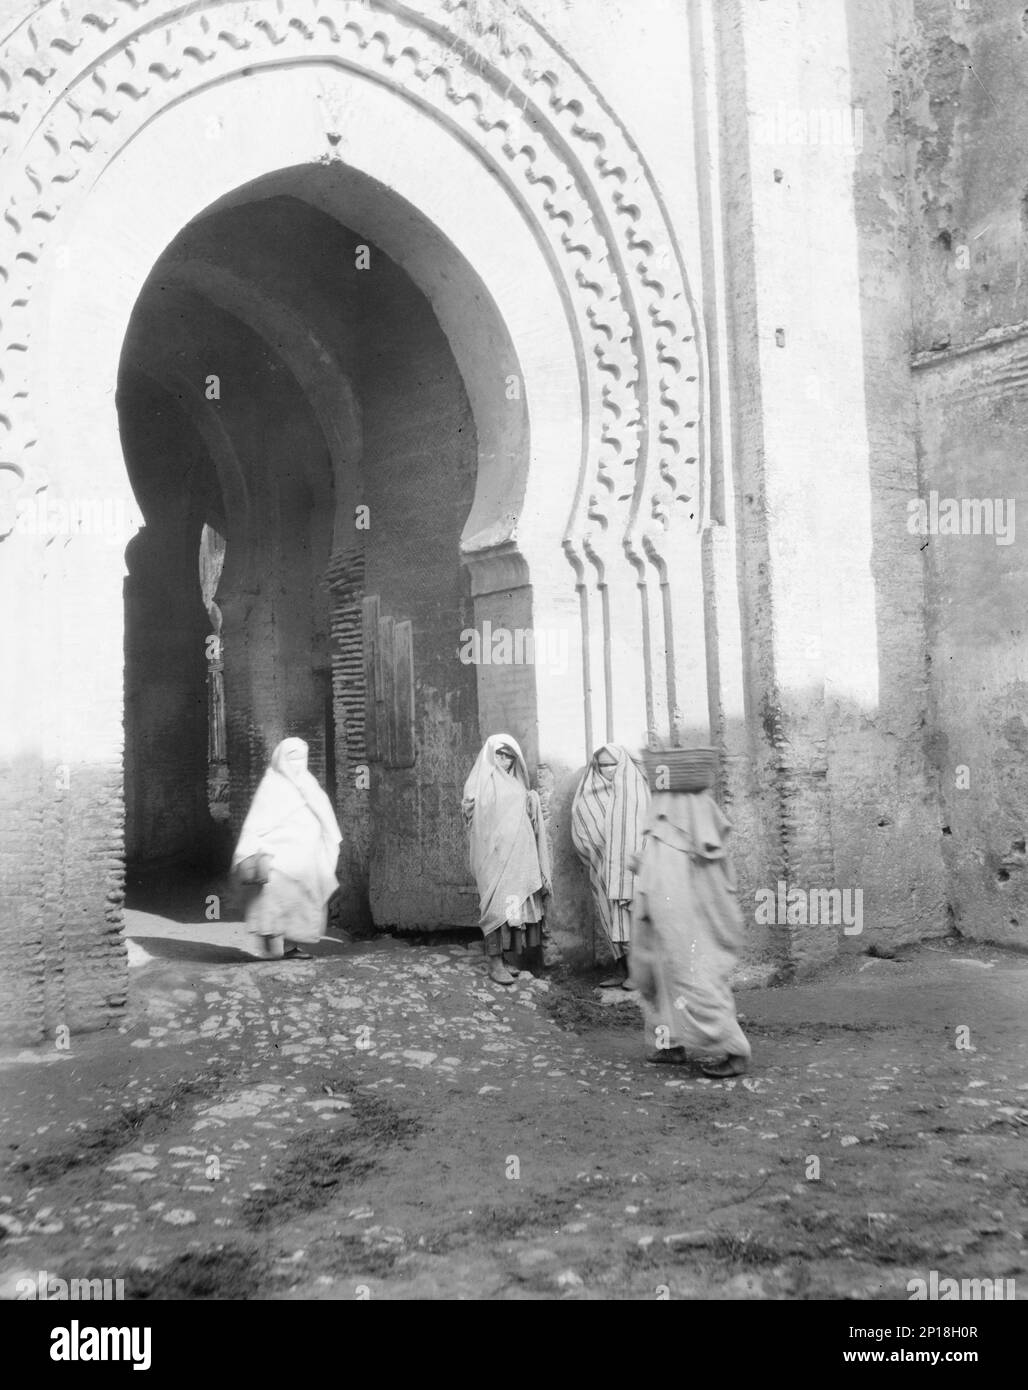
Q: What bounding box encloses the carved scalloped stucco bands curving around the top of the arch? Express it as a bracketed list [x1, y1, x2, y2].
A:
[0, 0, 702, 567]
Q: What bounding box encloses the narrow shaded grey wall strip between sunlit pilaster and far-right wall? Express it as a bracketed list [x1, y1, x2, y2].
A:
[828, 0, 949, 947]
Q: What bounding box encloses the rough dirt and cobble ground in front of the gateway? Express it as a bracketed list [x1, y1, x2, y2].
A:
[0, 912, 1028, 1300]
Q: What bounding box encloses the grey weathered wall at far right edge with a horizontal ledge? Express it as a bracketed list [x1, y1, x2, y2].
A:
[899, 0, 1028, 945]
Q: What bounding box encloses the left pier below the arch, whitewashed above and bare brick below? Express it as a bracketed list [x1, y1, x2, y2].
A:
[0, 537, 128, 1044]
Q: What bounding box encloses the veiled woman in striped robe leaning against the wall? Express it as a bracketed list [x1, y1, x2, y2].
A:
[571, 744, 650, 990]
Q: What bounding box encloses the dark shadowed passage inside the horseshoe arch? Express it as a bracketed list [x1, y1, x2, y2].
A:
[118, 170, 478, 927]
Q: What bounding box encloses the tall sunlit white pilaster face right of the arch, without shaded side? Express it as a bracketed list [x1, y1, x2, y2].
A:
[717, 0, 878, 969]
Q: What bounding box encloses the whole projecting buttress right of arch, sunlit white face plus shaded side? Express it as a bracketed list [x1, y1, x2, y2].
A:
[717, 0, 945, 970]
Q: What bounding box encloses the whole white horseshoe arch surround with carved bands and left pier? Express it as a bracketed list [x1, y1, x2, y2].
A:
[0, 0, 713, 1045]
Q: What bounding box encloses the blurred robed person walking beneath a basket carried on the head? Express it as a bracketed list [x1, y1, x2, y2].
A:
[632, 791, 750, 1077]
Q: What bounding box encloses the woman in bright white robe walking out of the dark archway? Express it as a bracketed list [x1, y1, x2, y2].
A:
[232, 738, 342, 960]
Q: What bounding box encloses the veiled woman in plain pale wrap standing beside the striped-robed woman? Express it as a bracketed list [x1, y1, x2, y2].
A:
[461, 734, 552, 984]
